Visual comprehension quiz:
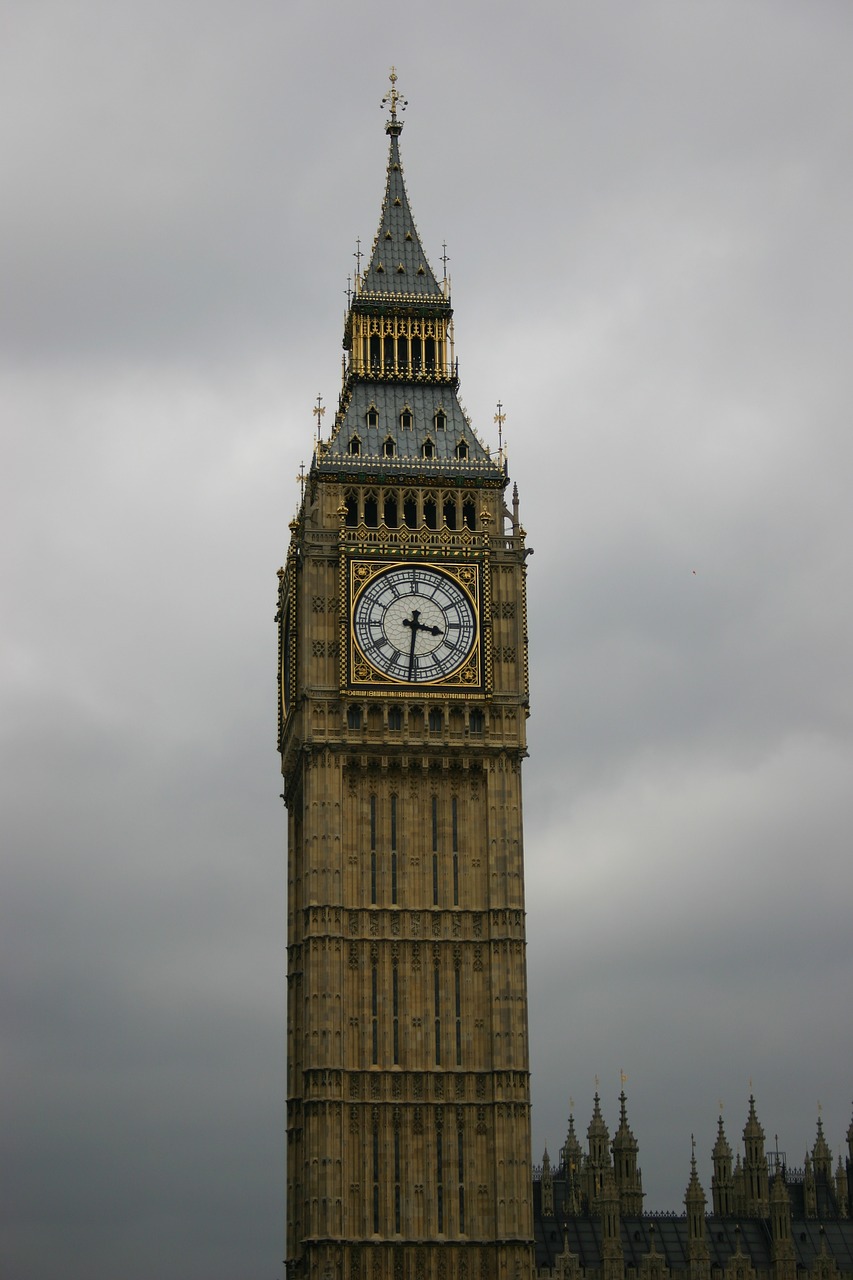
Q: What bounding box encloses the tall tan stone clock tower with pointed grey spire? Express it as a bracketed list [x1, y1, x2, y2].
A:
[278, 72, 533, 1280]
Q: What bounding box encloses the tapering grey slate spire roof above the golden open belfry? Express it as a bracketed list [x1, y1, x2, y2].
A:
[355, 132, 446, 305]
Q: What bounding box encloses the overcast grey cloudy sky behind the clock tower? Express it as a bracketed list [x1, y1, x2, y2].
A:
[0, 0, 853, 1280]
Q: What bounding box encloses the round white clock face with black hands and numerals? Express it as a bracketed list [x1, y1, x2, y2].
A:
[352, 564, 476, 685]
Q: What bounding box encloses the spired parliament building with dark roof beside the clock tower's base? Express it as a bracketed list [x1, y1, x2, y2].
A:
[533, 1091, 853, 1280]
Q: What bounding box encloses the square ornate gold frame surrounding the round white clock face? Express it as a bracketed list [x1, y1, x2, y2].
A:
[341, 557, 485, 698]
